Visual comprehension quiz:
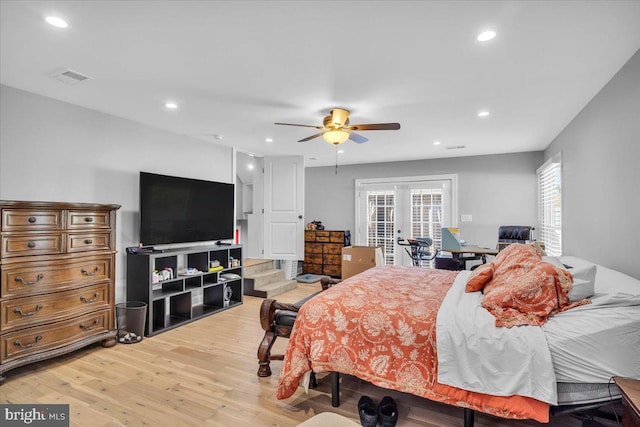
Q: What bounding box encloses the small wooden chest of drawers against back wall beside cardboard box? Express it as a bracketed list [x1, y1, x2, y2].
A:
[302, 230, 351, 278]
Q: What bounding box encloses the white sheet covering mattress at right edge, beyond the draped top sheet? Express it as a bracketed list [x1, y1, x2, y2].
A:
[542, 256, 640, 383]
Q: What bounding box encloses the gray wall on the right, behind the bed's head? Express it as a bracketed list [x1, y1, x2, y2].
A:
[544, 51, 640, 279]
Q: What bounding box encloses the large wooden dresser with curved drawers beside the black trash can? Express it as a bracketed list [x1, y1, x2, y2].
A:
[0, 200, 120, 381]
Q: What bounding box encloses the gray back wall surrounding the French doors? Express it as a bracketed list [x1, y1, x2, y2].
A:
[305, 152, 543, 247]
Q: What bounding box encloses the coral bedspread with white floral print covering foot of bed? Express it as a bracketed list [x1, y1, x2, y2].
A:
[277, 266, 549, 422]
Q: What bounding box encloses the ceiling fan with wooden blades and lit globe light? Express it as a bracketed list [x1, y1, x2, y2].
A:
[275, 108, 400, 145]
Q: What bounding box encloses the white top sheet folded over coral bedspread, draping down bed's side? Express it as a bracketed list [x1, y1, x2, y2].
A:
[436, 271, 558, 405]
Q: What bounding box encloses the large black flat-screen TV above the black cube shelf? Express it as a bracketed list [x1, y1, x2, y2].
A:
[140, 172, 234, 245]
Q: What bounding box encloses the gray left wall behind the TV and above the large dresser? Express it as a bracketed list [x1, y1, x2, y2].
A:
[0, 86, 234, 301]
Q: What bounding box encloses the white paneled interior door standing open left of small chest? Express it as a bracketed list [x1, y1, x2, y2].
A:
[264, 156, 304, 260]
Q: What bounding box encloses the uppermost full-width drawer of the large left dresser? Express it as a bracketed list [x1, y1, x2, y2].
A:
[1, 256, 112, 298]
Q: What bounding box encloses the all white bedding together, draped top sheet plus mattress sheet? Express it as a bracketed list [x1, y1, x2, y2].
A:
[436, 256, 640, 405]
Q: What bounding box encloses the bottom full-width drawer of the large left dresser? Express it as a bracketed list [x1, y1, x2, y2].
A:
[0, 310, 113, 363]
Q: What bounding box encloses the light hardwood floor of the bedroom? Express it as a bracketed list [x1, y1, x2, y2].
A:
[0, 283, 616, 427]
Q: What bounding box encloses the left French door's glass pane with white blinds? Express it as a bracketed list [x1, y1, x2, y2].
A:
[367, 190, 395, 265]
